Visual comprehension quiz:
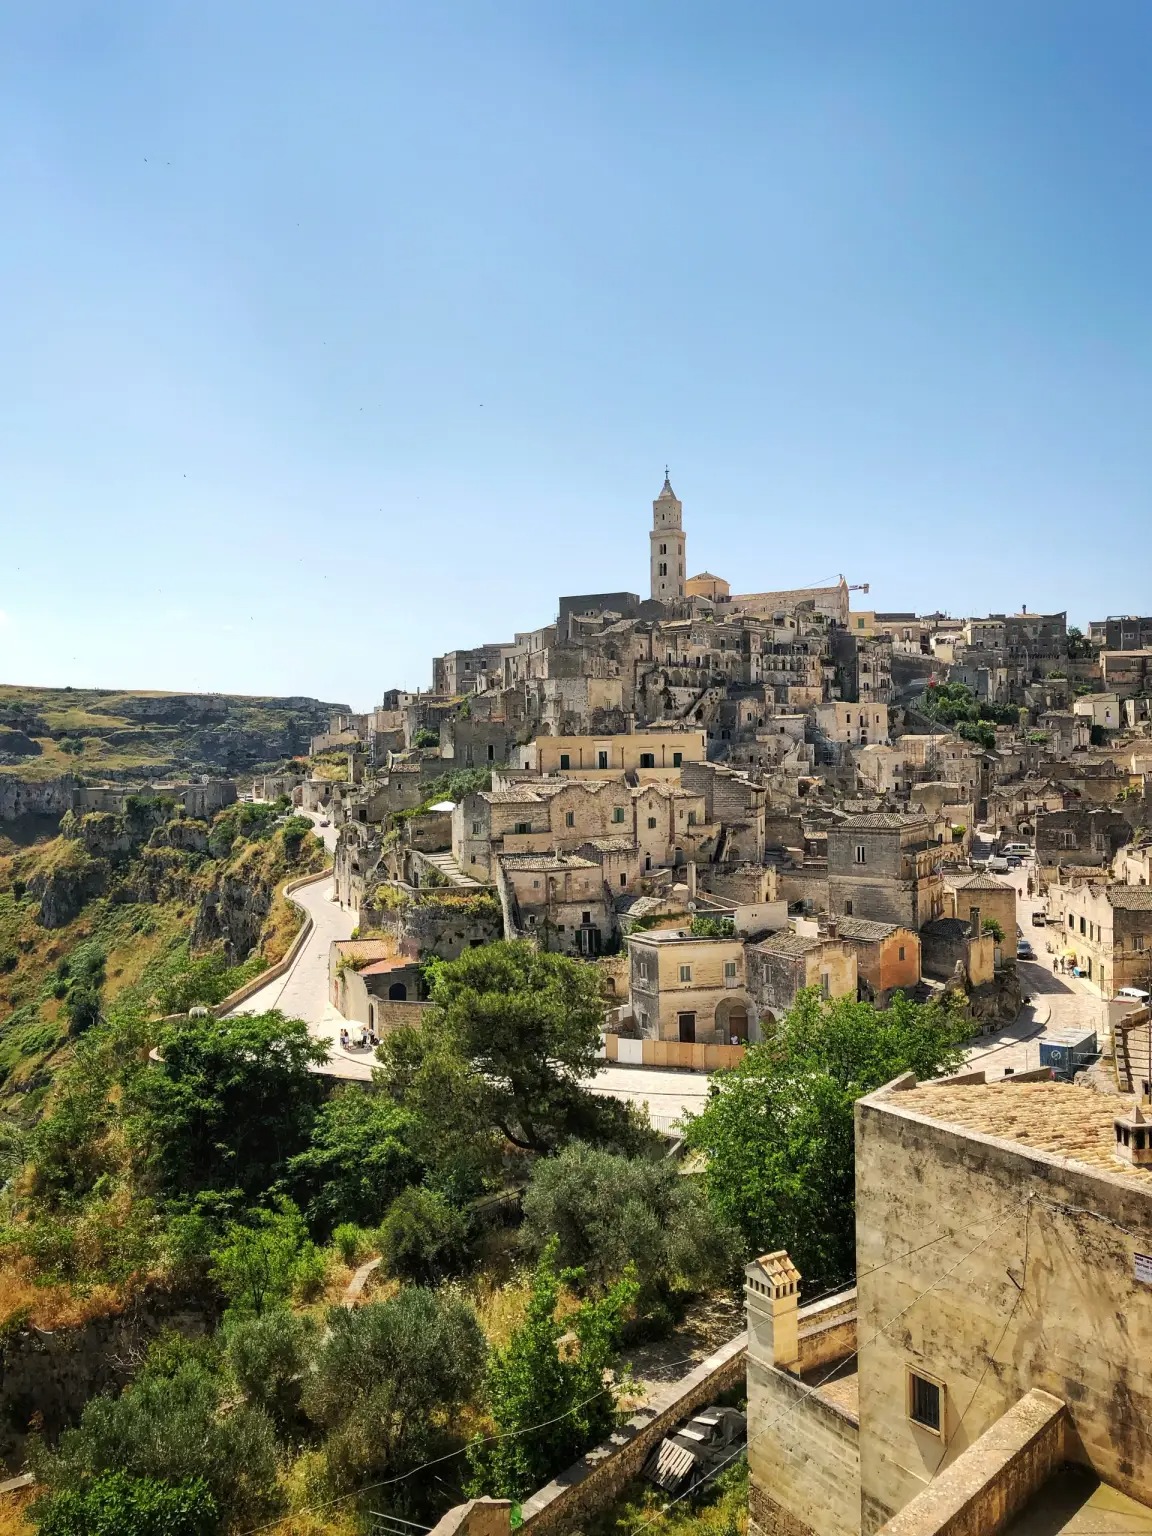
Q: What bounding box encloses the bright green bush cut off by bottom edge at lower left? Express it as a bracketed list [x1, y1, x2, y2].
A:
[31, 1471, 220, 1536]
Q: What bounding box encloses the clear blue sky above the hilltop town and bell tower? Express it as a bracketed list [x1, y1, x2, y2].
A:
[0, 0, 1152, 707]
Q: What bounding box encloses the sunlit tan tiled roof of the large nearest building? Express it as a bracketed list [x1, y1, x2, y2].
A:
[882, 1080, 1152, 1192]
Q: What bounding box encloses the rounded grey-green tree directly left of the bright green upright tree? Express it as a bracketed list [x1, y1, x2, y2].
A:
[304, 1286, 485, 1493]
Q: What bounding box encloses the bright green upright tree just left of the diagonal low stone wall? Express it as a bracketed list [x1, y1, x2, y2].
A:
[468, 1241, 639, 1499]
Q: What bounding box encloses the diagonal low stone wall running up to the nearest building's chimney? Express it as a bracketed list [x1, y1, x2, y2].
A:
[521, 1333, 746, 1536]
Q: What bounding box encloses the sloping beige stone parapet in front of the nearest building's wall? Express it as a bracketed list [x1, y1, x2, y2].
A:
[877, 1389, 1069, 1536]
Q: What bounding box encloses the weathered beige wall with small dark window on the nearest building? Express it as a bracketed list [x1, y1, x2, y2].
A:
[856, 1089, 1152, 1533]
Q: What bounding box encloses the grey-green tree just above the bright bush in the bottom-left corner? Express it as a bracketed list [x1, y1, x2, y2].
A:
[34, 1361, 276, 1531]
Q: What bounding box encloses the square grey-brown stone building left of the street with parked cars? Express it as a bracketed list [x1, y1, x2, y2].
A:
[828, 811, 943, 928]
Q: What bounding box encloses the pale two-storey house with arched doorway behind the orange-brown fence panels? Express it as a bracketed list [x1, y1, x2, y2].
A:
[628, 928, 760, 1046]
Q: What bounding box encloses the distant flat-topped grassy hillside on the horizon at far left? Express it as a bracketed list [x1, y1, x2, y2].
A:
[0, 684, 347, 779]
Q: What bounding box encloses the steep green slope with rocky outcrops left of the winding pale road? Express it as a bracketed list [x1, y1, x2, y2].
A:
[0, 806, 326, 1123]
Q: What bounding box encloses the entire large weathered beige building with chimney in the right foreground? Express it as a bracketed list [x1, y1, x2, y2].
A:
[745, 1072, 1152, 1536]
